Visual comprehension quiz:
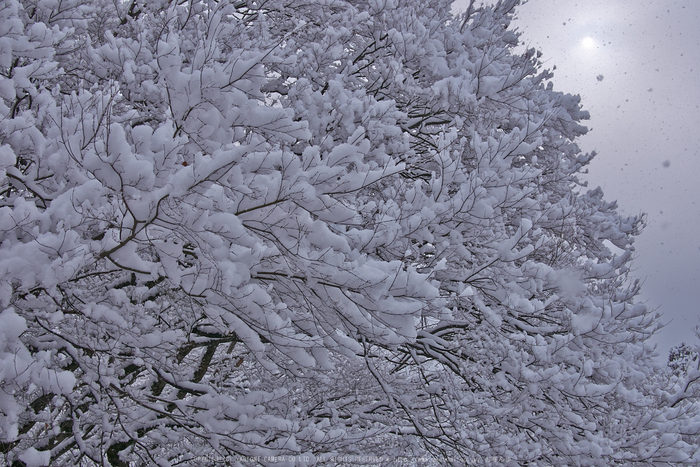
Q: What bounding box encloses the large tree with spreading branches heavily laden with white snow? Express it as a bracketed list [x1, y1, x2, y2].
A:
[0, 0, 700, 466]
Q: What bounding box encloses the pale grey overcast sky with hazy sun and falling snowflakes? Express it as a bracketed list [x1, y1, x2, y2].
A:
[456, 0, 700, 359]
